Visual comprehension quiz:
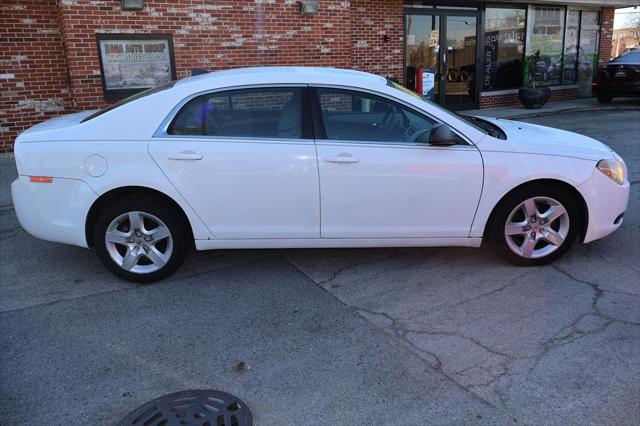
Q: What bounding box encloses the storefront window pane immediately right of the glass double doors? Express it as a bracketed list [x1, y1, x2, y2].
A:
[483, 7, 526, 90]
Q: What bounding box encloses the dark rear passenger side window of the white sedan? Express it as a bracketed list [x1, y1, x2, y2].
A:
[168, 88, 302, 139]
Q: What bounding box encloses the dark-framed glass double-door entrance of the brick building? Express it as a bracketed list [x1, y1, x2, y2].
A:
[405, 10, 478, 110]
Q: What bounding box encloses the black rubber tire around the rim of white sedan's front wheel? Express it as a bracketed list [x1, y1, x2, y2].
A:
[485, 183, 581, 266]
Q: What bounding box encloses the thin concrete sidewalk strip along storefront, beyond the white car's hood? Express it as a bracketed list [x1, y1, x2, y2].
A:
[459, 98, 640, 119]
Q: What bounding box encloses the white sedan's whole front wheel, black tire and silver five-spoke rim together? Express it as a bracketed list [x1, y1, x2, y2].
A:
[488, 185, 580, 266]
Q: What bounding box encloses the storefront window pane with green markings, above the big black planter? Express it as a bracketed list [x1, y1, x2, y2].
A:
[527, 6, 565, 86]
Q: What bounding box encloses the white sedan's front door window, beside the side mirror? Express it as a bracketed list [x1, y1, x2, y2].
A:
[318, 89, 435, 142]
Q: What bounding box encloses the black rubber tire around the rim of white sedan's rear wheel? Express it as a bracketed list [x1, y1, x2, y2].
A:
[93, 194, 191, 283]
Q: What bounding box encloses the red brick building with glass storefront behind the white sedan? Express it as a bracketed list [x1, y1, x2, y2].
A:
[0, 0, 633, 152]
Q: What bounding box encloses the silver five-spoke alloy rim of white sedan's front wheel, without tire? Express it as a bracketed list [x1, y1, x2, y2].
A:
[504, 197, 570, 259]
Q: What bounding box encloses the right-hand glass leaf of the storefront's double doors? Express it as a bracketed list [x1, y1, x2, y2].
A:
[442, 15, 477, 110]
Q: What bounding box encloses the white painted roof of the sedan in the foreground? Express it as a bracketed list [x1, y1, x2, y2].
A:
[174, 67, 387, 91]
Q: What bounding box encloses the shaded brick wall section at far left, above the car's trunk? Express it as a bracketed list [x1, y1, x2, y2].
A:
[0, 0, 72, 153]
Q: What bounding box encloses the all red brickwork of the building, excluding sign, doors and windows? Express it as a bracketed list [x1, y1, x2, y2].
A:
[0, 0, 614, 152]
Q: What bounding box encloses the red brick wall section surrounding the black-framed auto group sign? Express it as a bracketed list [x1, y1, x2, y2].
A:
[60, 0, 351, 109]
